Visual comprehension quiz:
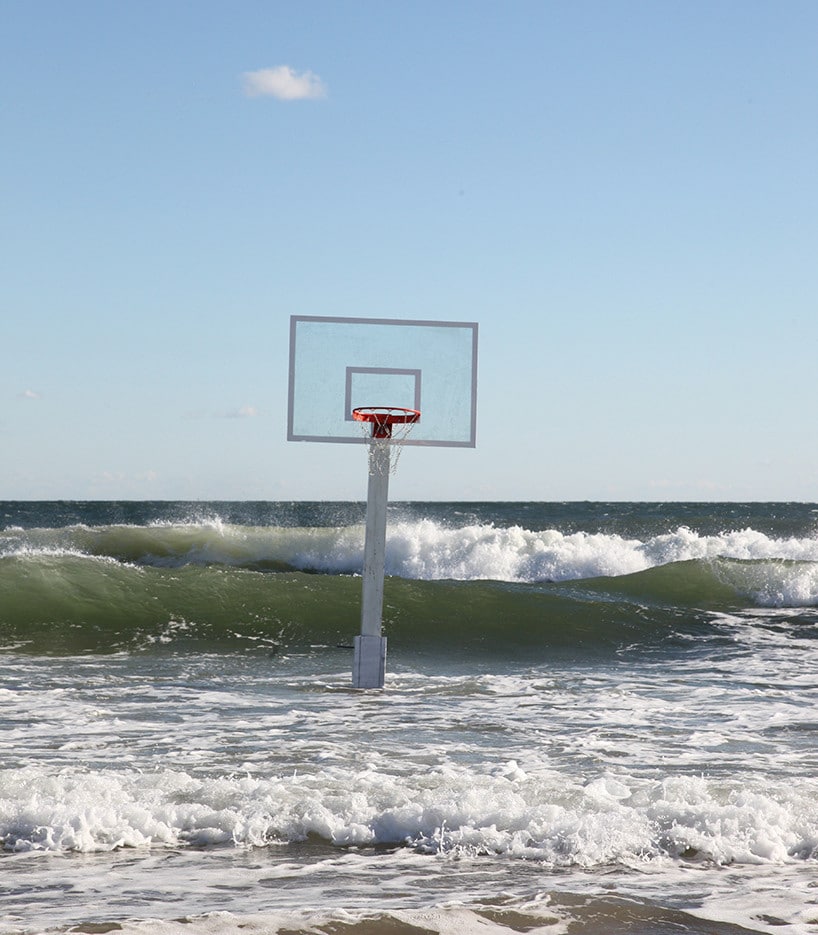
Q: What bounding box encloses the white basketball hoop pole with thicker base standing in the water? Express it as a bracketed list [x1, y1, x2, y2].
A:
[352, 440, 389, 688]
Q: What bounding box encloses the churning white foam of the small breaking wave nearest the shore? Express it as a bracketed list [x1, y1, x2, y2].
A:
[0, 763, 818, 868]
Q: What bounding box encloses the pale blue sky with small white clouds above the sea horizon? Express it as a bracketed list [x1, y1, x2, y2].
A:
[0, 0, 818, 502]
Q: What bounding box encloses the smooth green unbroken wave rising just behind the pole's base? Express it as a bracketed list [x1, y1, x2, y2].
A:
[0, 553, 780, 653]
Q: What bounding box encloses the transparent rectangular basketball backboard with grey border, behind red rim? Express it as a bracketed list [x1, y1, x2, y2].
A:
[287, 315, 477, 448]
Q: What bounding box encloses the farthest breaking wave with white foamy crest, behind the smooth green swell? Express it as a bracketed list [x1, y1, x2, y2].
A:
[0, 519, 818, 594]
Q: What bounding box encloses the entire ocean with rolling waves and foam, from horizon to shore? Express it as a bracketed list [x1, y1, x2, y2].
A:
[0, 502, 818, 935]
